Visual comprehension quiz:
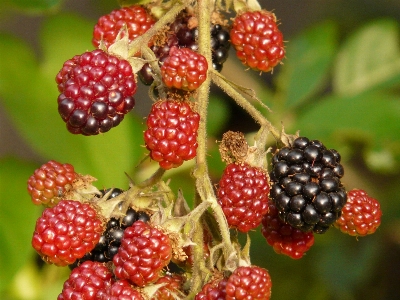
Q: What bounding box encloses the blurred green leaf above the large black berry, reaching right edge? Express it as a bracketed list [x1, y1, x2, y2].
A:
[295, 92, 400, 167]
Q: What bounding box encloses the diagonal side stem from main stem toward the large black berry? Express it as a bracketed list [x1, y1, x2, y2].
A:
[210, 70, 281, 140]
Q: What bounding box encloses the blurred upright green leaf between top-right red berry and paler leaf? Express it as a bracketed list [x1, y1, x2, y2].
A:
[278, 22, 337, 107]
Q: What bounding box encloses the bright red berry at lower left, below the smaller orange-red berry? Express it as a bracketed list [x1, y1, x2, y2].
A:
[32, 200, 103, 266]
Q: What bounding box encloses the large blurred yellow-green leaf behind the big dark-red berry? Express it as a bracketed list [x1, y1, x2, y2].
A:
[0, 15, 143, 187]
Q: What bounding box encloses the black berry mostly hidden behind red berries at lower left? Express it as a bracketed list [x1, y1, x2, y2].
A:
[69, 188, 150, 270]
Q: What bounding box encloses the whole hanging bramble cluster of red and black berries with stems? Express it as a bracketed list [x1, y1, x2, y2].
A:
[1, 0, 398, 300]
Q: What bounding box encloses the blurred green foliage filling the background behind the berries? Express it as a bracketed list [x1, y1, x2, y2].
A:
[0, 0, 400, 300]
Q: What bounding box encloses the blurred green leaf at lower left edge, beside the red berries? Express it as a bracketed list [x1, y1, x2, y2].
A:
[0, 159, 40, 291]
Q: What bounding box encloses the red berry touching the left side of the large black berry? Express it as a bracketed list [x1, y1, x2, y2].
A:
[218, 163, 269, 232]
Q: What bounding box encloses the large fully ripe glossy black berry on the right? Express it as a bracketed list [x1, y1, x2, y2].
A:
[270, 137, 347, 233]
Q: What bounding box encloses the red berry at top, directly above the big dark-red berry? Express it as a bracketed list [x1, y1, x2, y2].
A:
[92, 5, 155, 48]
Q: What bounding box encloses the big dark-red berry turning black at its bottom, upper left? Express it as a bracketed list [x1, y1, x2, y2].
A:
[56, 50, 136, 135]
